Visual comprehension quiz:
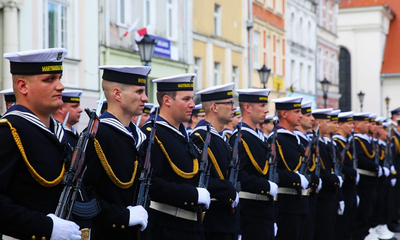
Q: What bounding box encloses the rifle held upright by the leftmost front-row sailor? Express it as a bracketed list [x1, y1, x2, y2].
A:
[55, 108, 103, 220]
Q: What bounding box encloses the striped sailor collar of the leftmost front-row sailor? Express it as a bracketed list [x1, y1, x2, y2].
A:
[2, 105, 65, 143]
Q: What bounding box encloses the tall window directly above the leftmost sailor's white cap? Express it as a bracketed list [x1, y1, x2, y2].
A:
[43, 0, 68, 48]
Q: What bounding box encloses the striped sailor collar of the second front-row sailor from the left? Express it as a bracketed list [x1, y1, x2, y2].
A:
[99, 111, 146, 150]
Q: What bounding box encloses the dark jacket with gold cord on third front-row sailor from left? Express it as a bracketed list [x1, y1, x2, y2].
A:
[142, 116, 203, 232]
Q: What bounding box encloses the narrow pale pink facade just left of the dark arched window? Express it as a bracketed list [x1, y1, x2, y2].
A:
[316, 0, 341, 109]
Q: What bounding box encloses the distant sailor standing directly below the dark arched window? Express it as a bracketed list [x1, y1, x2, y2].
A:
[333, 111, 360, 240]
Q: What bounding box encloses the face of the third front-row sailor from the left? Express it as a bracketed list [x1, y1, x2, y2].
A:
[167, 91, 195, 123]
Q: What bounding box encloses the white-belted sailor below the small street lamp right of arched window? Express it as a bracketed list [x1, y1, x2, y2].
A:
[353, 112, 382, 240]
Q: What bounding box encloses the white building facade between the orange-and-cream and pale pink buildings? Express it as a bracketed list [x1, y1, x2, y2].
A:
[285, 0, 317, 108]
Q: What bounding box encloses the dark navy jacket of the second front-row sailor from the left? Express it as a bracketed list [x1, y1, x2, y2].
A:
[84, 112, 146, 239]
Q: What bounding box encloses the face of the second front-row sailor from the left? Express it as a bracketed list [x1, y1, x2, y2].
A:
[121, 85, 149, 116]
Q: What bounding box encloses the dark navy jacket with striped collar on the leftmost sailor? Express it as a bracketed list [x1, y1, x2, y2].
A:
[0, 105, 69, 239]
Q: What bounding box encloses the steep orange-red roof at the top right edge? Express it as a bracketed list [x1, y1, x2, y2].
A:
[381, 0, 400, 73]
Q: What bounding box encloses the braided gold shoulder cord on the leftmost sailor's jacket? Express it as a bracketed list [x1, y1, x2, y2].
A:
[0, 119, 65, 187]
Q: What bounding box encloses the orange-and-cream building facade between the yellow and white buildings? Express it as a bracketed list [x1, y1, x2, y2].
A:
[250, 0, 287, 113]
